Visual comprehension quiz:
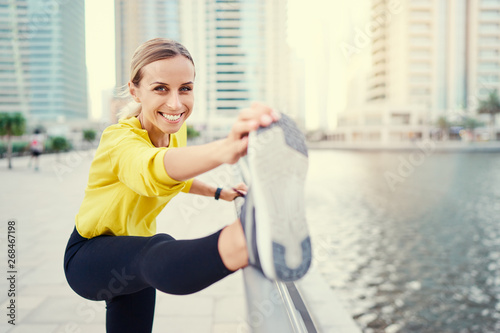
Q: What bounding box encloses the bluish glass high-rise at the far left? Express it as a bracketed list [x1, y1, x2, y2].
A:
[0, 0, 88, 123]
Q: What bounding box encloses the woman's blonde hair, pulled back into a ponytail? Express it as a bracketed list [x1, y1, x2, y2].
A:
[118, 38, 194, 119]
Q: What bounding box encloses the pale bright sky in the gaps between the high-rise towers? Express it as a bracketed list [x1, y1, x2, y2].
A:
[85, 0, 370, 129]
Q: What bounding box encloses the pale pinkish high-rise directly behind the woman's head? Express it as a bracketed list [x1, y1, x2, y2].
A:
[115, 0, 180, 87]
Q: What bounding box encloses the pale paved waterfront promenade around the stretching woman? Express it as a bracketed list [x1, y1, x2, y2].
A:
[0, 151, 359, 333]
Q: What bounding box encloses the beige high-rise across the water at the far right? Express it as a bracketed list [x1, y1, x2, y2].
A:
[332, 0, 500, 142]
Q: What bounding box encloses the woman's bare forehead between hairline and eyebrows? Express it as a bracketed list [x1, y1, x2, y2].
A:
[143, 55, 194, 84]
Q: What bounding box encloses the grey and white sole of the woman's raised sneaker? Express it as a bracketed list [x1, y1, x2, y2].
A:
[253, 115, 311, 281]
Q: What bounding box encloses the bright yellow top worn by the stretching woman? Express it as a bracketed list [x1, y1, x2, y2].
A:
[76, 117, 193, 238]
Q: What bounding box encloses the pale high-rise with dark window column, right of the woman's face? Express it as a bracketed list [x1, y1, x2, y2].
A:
[181, 0, 297, 136]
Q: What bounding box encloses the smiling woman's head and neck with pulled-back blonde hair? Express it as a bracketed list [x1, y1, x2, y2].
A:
[128, 39, 195, 147]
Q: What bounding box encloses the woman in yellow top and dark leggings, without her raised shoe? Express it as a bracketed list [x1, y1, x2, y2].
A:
[64, 39, 308, 333]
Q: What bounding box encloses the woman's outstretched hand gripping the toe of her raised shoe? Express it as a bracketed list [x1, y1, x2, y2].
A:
[224, 102, 280, 164]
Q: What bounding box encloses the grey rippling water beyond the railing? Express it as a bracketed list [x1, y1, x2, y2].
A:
[307, 151, 500, 333]
